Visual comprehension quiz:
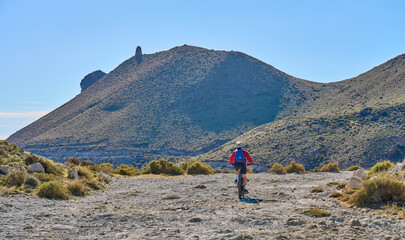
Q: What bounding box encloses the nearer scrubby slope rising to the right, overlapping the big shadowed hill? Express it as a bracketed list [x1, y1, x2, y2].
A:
[199, 55, 405, 168]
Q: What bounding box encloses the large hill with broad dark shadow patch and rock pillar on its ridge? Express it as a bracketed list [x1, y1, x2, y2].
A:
[8, 45, 314, 166]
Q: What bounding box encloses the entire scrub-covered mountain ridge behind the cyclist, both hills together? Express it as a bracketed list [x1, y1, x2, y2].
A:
[8, 45, 405, 168]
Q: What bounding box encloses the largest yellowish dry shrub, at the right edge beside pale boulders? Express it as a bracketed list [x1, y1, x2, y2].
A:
[349, 175, 405, 207]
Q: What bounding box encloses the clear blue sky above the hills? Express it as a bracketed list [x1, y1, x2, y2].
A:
[0, 0, 405, 139]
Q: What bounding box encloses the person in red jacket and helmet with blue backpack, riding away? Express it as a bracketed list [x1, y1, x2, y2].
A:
[229, 142, 253, 193]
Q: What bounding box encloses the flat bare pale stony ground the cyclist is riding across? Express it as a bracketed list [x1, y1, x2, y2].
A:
[0, 172, 405, 239]
